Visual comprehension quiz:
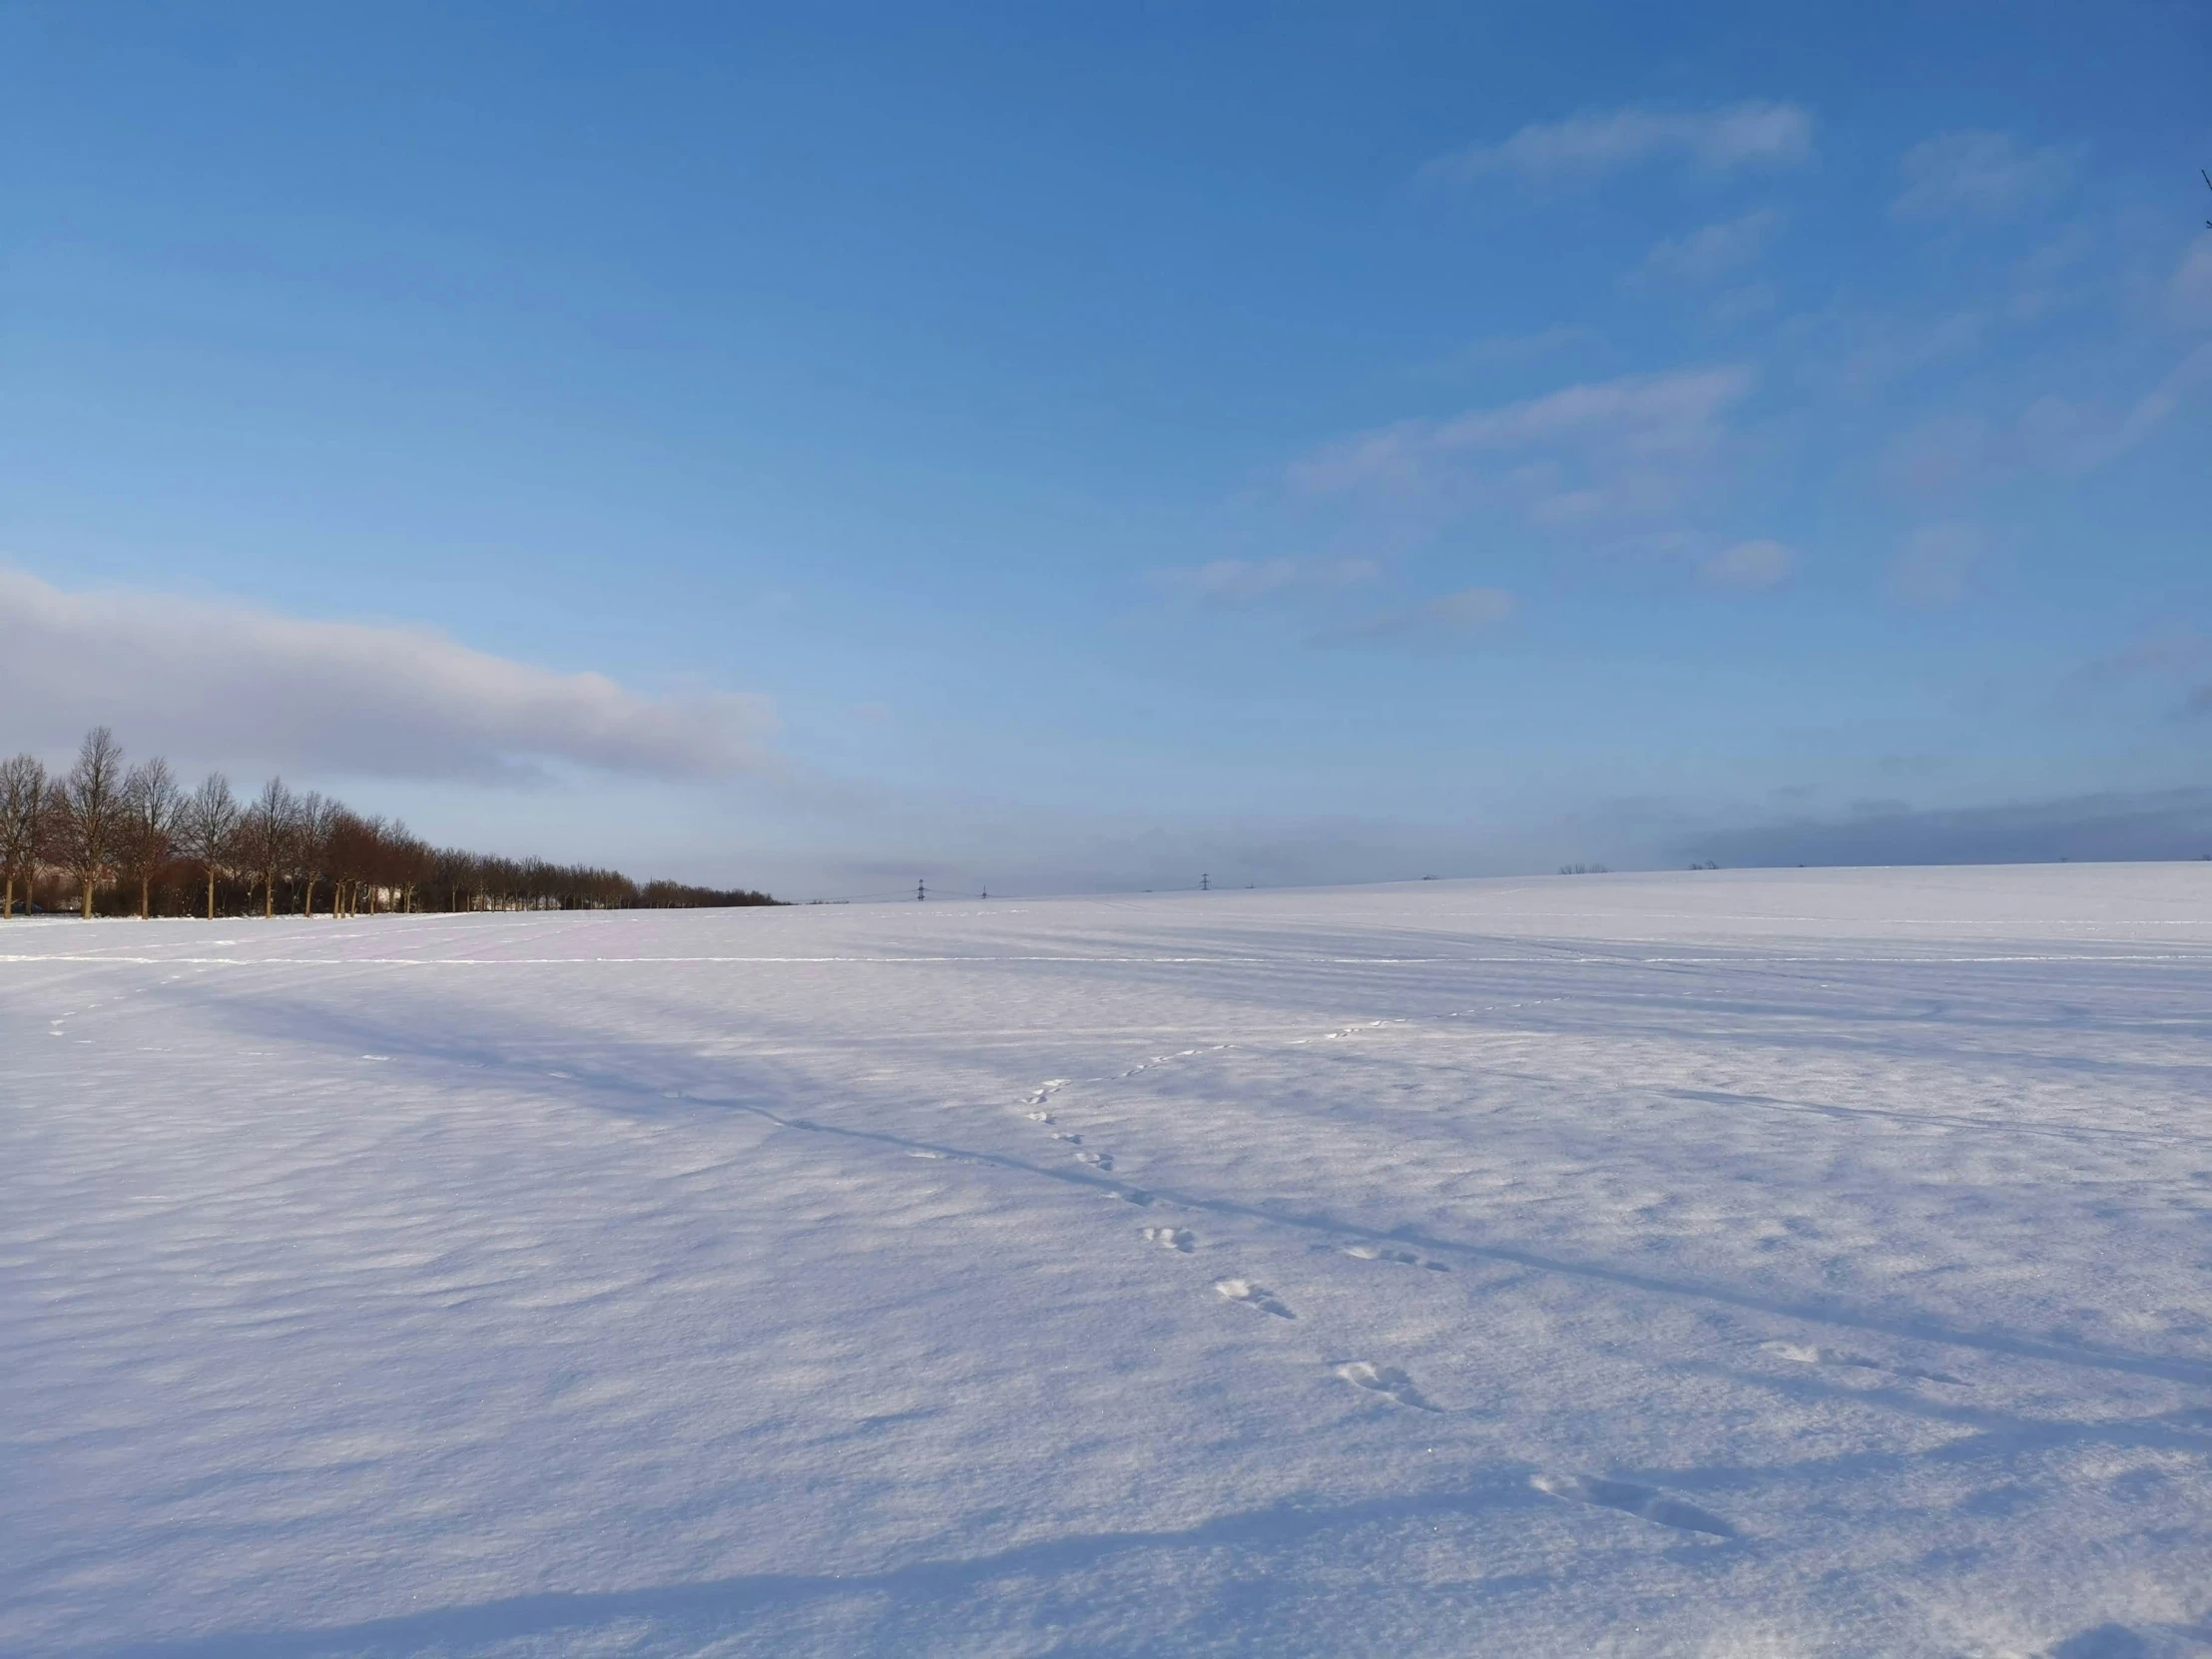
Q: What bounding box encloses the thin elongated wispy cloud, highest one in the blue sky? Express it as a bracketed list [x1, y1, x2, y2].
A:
[1429, 102, 1812, 179]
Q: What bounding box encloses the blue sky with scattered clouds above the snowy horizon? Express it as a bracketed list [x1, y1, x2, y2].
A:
[0, 4, 2212, 898]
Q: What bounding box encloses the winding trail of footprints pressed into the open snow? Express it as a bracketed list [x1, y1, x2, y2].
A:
[999, 997, 1966, 1539]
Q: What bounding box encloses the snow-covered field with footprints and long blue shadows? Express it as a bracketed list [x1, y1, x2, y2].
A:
[0, 864, 2212, 1659]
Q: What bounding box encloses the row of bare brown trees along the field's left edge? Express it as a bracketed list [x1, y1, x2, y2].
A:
[0, 726, 777, 918]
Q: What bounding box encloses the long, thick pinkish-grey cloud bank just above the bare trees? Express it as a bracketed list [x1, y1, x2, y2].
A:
[0, 569, 775, 779]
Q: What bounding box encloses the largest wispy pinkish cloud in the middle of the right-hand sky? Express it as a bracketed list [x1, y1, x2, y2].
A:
[1285, 367, 1754, 529]
